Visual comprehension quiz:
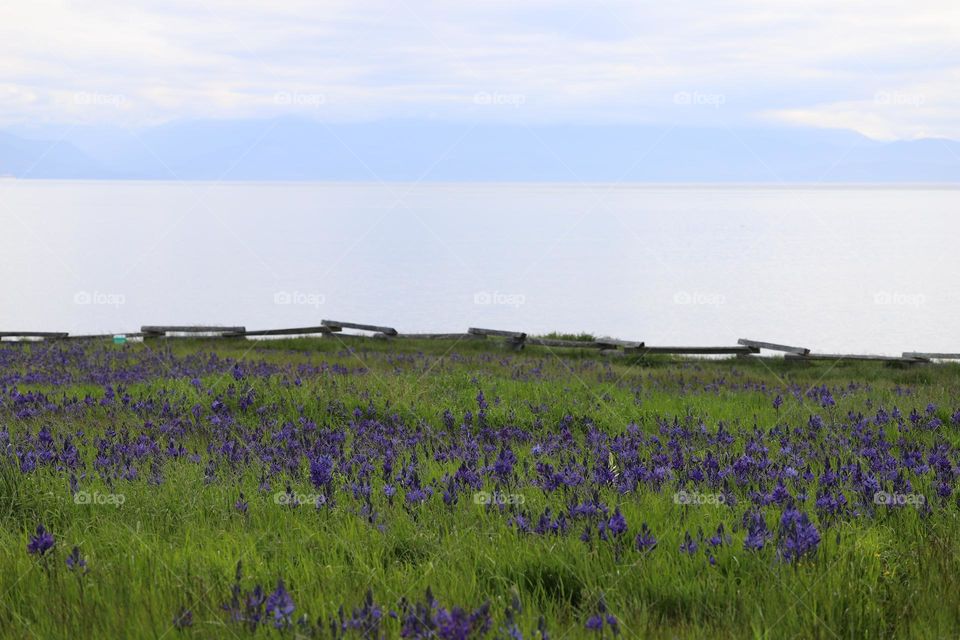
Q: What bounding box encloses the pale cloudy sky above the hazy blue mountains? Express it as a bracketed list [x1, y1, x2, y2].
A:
[0, 0, 960, 140]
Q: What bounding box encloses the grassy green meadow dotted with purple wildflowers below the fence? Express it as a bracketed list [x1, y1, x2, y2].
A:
[0, 339, 960, 640]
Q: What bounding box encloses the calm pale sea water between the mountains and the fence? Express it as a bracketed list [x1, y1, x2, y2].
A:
[0, 181, 960, 353]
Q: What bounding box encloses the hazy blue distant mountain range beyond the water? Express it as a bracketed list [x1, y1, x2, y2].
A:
[0, 118, 960, 183]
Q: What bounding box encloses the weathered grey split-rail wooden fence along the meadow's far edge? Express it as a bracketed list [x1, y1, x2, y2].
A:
[0, 320, 960, 364]
